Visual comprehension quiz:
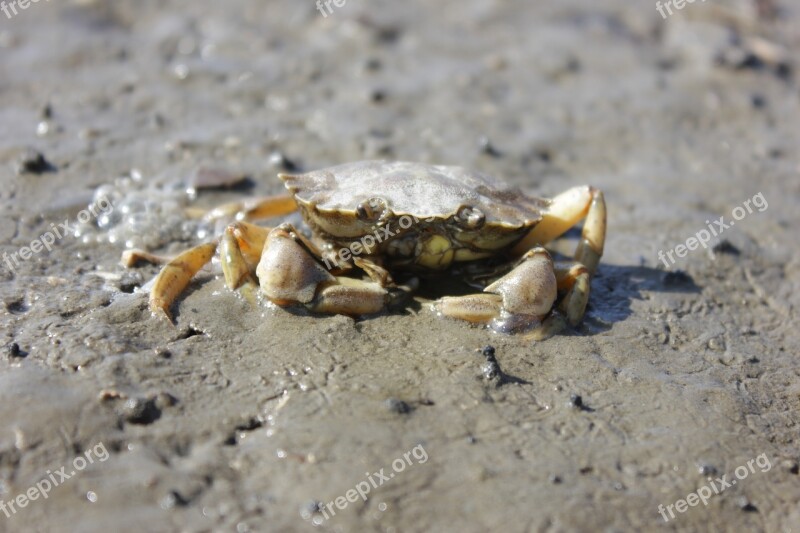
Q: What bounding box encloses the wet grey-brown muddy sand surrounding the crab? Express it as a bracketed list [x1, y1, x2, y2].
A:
[0, 0, 800, 533]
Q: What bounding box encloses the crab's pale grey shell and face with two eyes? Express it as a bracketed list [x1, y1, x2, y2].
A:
[279, 161, 550, 270]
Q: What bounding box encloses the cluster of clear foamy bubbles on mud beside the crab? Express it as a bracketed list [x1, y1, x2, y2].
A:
[75, 170, 213, 250]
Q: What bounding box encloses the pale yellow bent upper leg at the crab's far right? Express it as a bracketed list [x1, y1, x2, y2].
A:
[512, 186, 606, 274]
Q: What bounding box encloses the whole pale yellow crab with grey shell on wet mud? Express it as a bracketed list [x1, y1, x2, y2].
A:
[123, 161, 606, 338]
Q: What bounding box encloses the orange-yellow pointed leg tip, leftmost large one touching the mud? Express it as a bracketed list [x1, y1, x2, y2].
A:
[150, 241, 217, 321]
